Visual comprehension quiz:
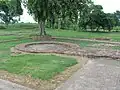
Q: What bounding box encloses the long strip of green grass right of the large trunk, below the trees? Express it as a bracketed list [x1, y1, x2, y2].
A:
[47, 29, 120, 41]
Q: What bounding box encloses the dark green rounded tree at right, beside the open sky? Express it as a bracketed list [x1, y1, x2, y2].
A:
[82, 5, 114, 31]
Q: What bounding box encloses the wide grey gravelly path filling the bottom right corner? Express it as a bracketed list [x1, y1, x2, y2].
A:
[56, 58, 120, 90]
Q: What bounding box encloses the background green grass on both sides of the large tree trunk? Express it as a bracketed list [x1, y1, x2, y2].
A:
[0, 23, 120, 41]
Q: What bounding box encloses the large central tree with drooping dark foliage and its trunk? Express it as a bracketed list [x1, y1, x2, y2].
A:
[24, 0, 90, 35]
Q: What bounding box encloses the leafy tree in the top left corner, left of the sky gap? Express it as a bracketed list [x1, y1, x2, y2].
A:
[0, 0, 23, 25]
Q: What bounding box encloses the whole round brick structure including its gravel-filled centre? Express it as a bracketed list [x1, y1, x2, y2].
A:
[14, 41, 79, 54]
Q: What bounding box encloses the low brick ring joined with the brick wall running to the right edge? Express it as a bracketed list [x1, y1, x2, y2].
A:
[11, 41, 120, 60]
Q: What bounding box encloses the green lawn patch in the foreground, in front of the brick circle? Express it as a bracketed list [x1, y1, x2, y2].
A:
[0, 55, 77, 80]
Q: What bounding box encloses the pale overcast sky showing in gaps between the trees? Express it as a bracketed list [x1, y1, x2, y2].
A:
[21, 0, 120, 22]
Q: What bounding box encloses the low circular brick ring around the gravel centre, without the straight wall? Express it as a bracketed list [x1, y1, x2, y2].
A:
[12, 41, 80, 54]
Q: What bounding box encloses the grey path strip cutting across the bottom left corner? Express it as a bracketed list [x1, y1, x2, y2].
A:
[0, 79, 32, 90]
